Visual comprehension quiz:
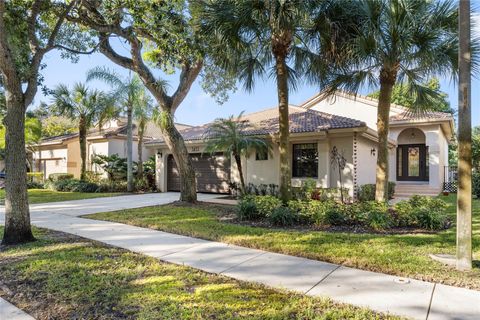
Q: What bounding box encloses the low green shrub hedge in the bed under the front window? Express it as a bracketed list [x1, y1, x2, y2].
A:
[237, 196, 450, 231]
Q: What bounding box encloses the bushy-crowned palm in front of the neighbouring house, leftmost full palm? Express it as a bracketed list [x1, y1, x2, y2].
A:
[52, 82, 116, 180]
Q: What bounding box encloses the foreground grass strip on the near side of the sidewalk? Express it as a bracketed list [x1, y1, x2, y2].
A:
[0, 227, 397, 319]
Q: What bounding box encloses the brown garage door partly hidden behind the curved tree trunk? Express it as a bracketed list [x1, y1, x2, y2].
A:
[167, 153, 230, 193]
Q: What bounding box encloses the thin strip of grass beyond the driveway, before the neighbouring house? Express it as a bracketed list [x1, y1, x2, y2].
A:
[0, 189, 122, 204]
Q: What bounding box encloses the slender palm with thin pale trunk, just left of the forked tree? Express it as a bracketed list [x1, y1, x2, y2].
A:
[87, 67, 145, 192]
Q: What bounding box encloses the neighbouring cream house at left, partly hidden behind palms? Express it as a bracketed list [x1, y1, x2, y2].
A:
[32, 118, 188, 178]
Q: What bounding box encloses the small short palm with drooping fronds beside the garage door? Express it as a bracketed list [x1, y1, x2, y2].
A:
[204, 112, 271, 193]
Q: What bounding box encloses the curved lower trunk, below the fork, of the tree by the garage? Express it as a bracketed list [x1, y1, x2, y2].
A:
[162, 108, 197, 203]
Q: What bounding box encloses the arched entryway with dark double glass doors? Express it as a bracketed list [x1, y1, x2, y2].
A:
[397, 128, 429, 181]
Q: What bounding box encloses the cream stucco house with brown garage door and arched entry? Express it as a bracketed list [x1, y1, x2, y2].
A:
[145, 92, 454, 197]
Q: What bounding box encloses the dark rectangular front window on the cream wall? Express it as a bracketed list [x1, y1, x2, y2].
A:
[292, 143, 318, 178]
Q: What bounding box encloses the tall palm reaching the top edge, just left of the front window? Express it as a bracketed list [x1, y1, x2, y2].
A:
[201, 0, 356, 201]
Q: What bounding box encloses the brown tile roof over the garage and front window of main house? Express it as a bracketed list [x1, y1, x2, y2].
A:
[146, 109, 366, 144]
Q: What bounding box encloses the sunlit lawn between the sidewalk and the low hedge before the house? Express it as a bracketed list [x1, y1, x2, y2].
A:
[87, 195, 480, 289]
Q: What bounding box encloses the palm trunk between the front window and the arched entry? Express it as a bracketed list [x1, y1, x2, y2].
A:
[375, 69, 397, 202]
